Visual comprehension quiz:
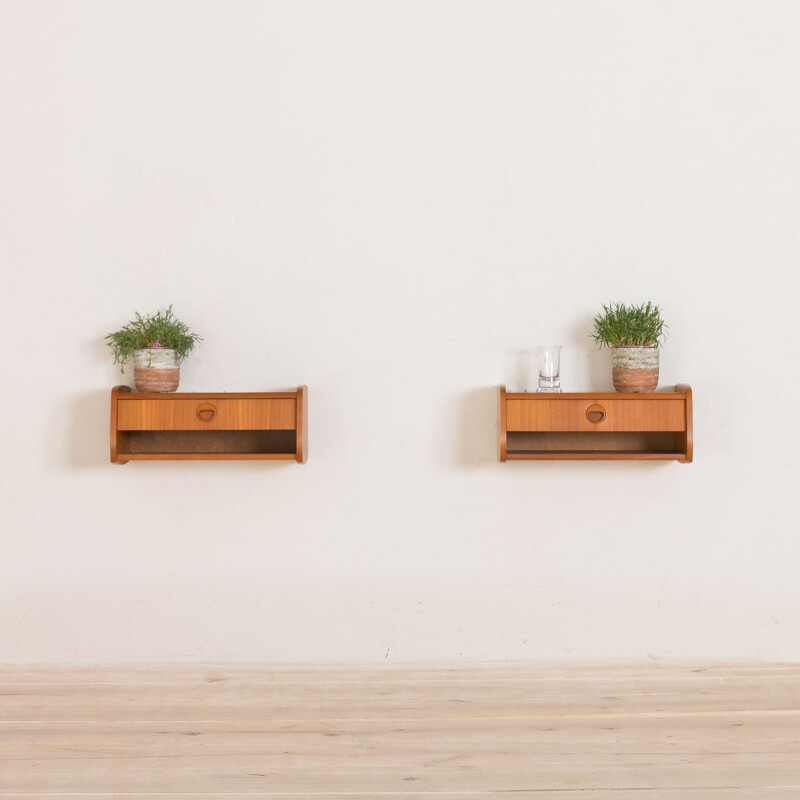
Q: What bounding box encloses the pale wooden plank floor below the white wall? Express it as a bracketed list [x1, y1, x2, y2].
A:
[0, 662, 800, 800]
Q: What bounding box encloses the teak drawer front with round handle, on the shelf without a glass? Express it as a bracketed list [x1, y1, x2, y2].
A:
[117, 398, 297, 431]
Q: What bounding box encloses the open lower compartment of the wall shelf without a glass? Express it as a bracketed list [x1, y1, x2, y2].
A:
[117, 430, 297, 461]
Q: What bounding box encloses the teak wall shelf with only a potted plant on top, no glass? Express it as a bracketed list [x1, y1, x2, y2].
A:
[111, 386, 308, 464]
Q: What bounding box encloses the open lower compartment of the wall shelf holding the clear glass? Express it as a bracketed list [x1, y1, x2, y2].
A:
[506, 431, 686, 461]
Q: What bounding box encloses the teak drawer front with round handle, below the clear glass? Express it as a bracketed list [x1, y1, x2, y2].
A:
[506, 398, 686, 432]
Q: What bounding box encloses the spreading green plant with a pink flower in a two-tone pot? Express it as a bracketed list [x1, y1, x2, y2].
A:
[106, 306, 200, 392]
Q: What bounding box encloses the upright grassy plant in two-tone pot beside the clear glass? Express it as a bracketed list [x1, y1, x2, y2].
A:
[592, 302, 665, 392]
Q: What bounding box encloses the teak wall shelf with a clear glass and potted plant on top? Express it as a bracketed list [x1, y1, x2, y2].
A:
[497, 384, 692, 462]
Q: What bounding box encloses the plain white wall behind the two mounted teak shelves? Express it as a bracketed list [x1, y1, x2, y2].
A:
[0, 0, 800, 664]
